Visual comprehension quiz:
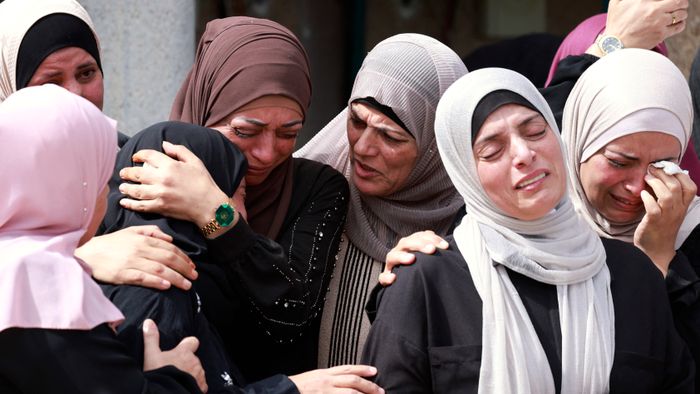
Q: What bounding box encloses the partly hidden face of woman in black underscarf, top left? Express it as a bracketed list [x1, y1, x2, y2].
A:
[27, 47, 104, 109]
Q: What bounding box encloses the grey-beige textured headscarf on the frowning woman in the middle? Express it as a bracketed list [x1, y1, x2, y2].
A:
[294, 34, 467, 261]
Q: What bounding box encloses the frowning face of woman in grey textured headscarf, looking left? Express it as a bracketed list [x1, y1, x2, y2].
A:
[347, 103, 418, 197]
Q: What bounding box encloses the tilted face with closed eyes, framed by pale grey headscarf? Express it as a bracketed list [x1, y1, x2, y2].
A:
[473, 104, 566, 220]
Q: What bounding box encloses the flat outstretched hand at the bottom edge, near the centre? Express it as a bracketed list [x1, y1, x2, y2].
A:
[289, 365, 384, 394]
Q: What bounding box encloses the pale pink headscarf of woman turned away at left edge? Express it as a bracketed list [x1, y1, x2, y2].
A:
[0, 85, 123, 331]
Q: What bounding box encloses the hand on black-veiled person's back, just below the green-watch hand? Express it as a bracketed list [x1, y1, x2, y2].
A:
[75, 226, 198, 290]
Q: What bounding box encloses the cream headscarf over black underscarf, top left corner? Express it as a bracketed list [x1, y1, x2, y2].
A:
[0, 0, 99, 102]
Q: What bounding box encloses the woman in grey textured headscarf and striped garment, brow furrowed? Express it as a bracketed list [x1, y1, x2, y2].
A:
[296, 34, 467, 367]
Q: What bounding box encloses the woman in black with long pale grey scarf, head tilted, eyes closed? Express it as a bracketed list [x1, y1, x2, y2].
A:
[363, 69, 693, 393]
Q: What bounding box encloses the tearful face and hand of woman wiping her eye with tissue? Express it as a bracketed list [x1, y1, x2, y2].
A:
[580, 131, 697, 275]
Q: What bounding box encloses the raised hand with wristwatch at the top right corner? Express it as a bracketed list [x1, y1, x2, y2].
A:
[605, 0, 688, 49]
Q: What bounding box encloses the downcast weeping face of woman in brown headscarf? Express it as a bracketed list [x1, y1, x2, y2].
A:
[212, 100, 304, 186]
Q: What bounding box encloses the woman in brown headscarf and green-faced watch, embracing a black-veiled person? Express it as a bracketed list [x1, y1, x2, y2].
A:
[103, 17, 348, 380]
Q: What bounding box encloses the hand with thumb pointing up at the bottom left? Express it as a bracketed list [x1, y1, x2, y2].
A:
[143, 319, 208, 393]
